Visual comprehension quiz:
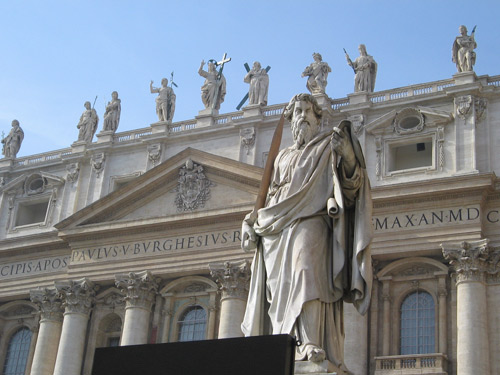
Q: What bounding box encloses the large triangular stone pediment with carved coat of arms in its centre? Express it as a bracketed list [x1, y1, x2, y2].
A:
[55, 148, 262, 237]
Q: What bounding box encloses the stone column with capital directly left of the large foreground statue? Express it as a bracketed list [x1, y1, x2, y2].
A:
[209, 260, 250, 339]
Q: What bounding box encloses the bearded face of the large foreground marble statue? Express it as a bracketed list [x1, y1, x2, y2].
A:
[292, 101, 319, 148]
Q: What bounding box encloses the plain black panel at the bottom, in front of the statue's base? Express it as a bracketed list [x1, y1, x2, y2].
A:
[92, 335, 295, 375]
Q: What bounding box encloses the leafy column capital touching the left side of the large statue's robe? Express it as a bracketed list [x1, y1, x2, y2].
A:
[209, 260, 250, 300]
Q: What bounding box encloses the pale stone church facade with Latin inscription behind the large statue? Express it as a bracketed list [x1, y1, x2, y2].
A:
[0, 72, 500, 375]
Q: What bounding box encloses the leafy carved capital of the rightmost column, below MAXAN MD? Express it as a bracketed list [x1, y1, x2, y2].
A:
[441, 239, 500, 284]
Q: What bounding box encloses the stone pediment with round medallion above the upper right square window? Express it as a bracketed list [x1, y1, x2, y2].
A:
[365, 106, 453, 136]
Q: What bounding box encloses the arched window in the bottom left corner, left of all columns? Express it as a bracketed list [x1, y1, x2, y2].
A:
[3, 327, 31, 375]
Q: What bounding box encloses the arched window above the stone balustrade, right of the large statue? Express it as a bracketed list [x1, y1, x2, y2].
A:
[400, 290, 436, 355]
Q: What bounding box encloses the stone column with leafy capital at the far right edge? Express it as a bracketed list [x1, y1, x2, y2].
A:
[441, 240, 490, 374]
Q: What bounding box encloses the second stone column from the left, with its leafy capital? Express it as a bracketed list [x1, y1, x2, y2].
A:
[54, 278, 95, 375]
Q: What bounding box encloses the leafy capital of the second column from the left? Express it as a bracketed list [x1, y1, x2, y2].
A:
[54, 278, 96, 315]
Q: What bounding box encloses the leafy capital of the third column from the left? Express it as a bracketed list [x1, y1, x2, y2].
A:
[115, 271, 158, 311]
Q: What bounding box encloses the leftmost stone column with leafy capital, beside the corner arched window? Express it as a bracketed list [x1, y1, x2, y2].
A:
[30, 288, 63, 375]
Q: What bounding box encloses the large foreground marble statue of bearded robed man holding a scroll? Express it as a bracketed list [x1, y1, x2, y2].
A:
[241, 94, 372, 370]
